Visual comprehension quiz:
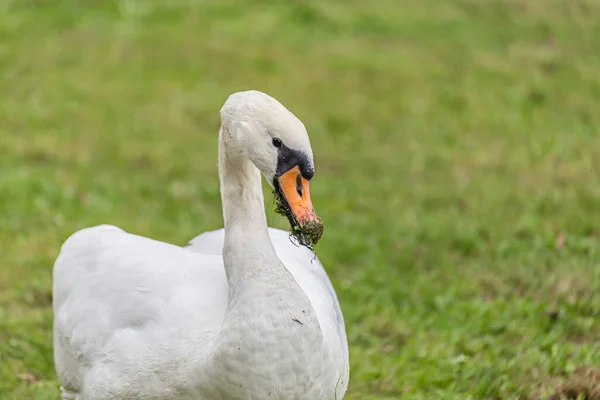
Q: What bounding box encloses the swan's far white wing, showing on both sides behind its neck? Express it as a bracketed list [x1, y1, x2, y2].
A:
[186, 228, 348, 385]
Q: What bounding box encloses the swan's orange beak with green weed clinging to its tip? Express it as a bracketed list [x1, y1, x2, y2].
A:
[274, 166, 323, 247]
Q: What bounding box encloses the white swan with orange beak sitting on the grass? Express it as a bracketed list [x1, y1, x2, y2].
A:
[53, 90, 349, 400]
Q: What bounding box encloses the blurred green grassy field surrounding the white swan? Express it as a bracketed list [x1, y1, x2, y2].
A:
[0, 0, 600, 400]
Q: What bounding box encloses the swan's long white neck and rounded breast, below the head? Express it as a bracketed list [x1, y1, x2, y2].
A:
[199, 129, 327, 398]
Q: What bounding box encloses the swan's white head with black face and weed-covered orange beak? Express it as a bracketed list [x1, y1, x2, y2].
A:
[221, 90, 323, 247]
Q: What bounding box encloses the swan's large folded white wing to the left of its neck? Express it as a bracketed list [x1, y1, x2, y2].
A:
[53, 225, 228, 391]
